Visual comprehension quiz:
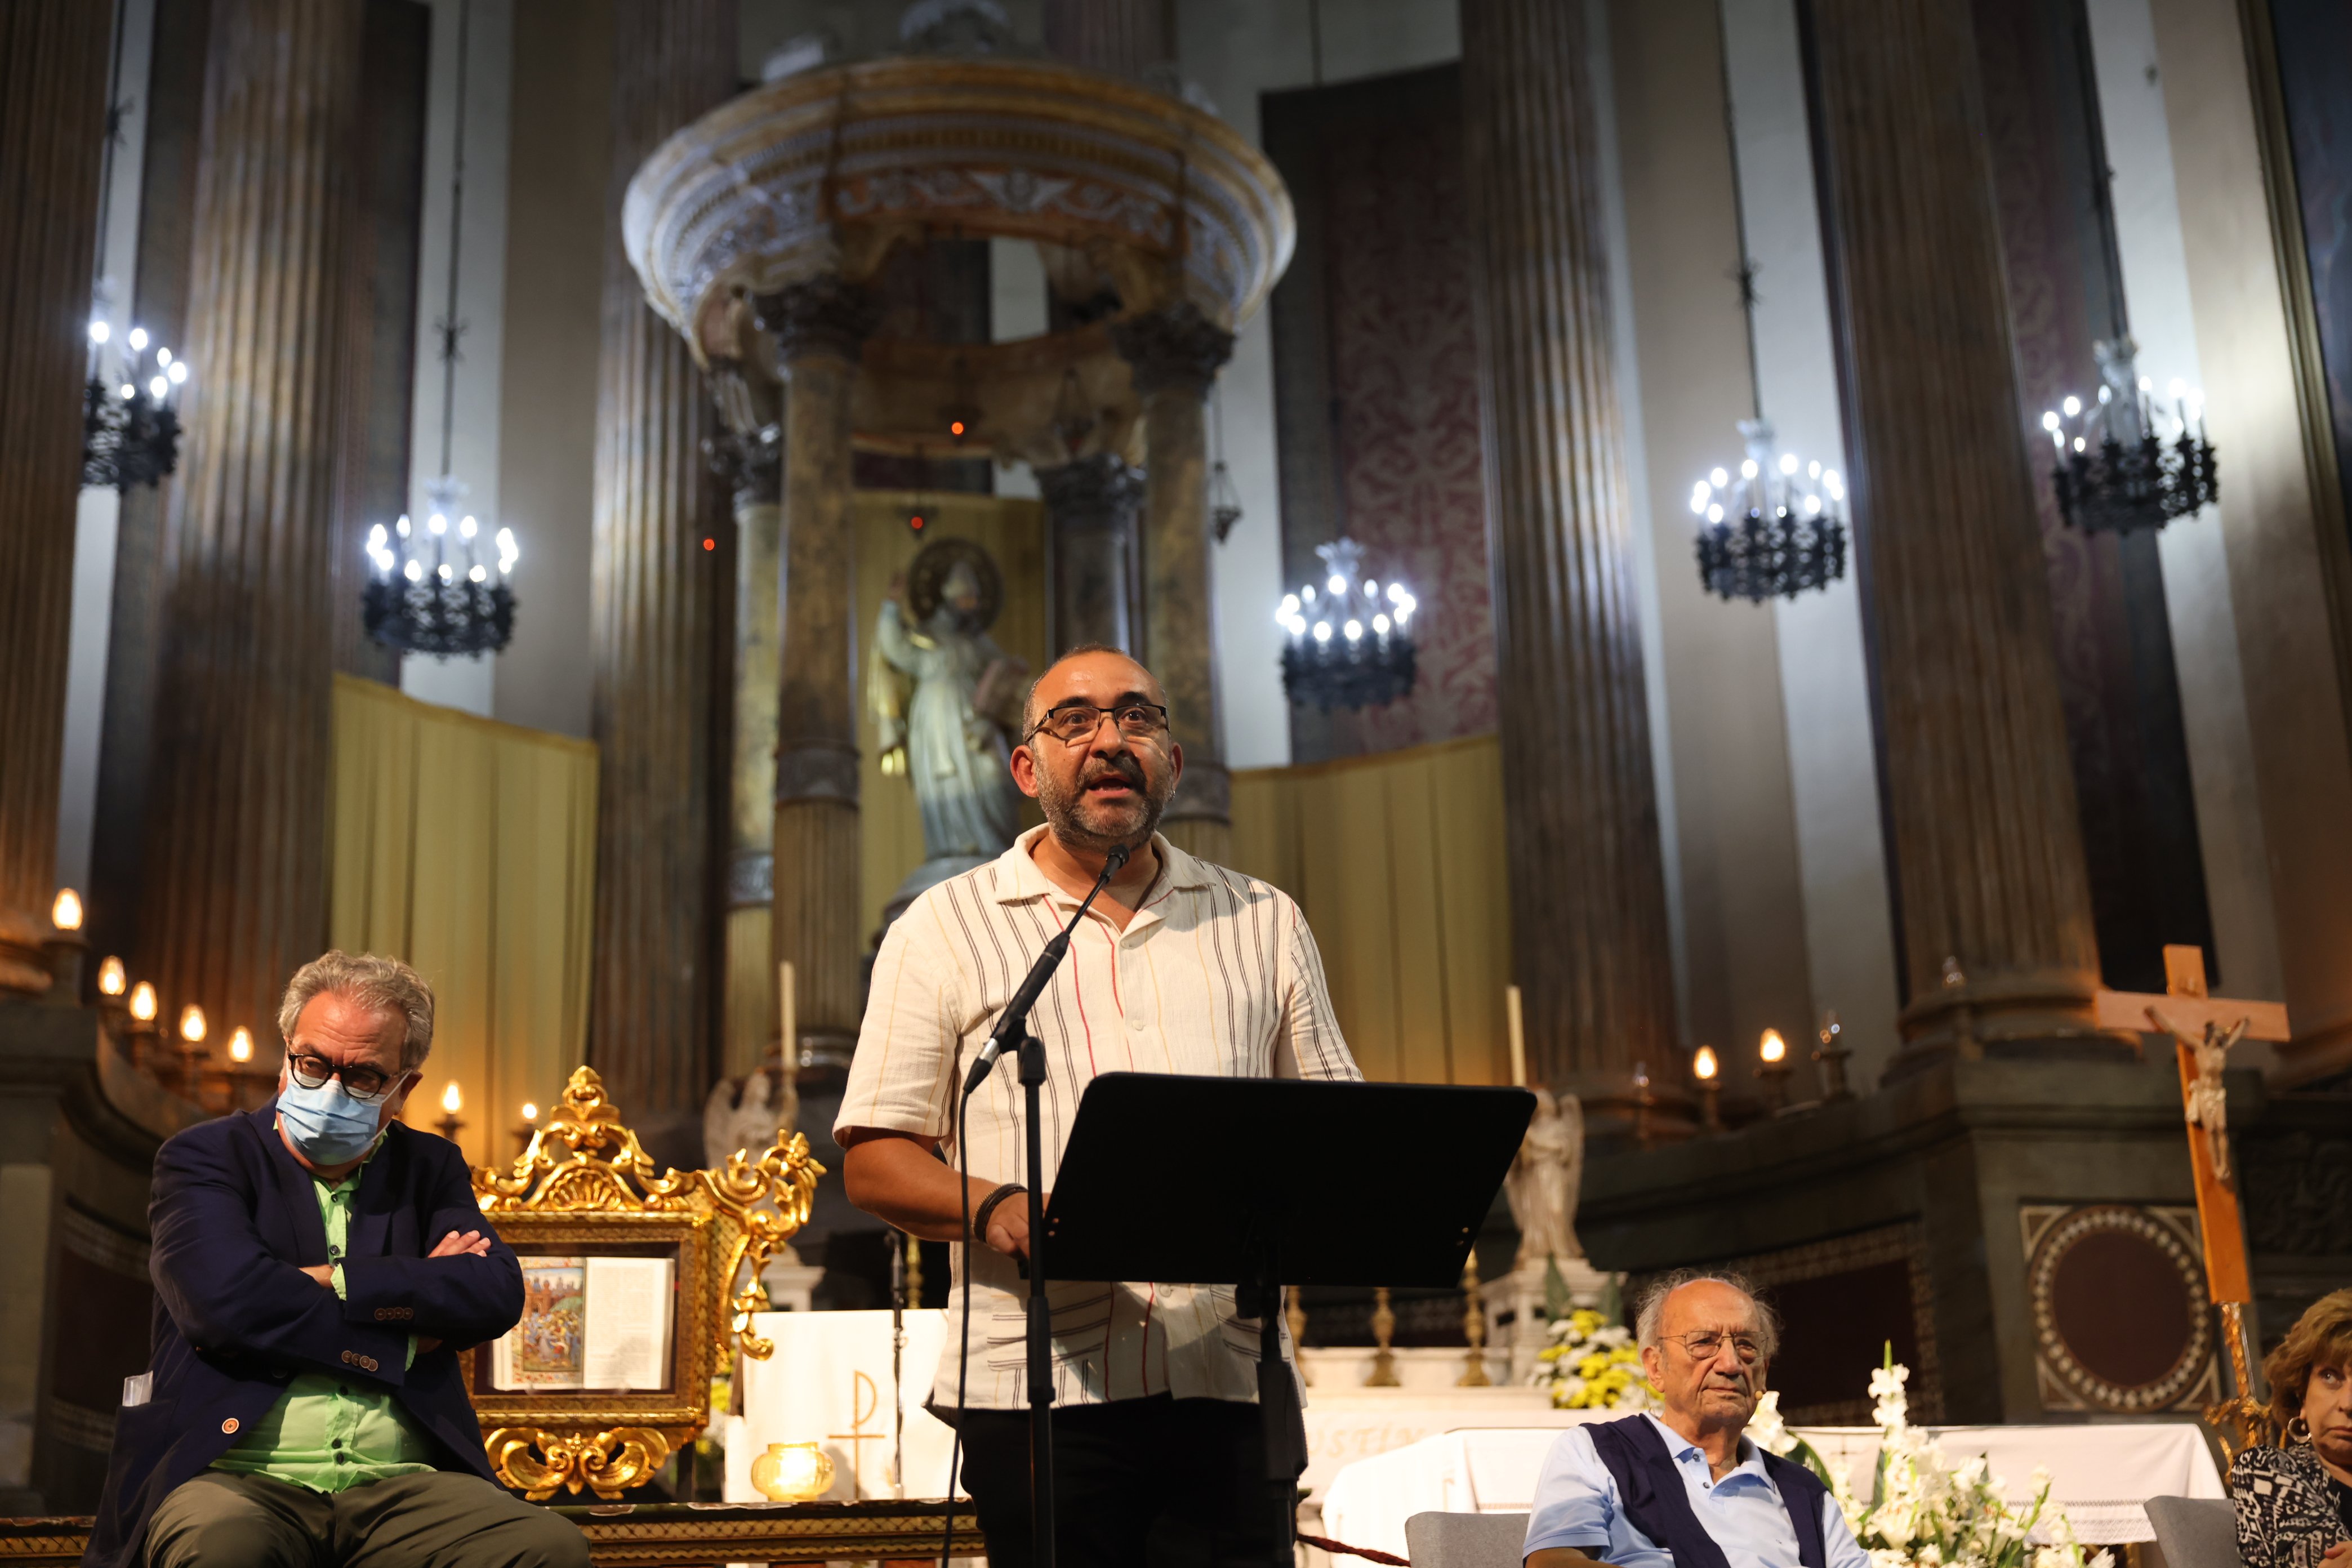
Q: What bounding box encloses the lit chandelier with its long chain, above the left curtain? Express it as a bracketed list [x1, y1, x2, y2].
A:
[360, 0, 522, 658]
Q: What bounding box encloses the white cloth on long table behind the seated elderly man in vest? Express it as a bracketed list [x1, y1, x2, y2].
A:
[1322, 1410, 2228, 1556]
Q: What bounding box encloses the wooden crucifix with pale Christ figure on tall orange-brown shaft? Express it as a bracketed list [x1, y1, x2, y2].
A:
[2098, 945, 2288, 1453]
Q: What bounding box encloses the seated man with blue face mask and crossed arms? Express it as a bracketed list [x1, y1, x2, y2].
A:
[82, 952, 588, 1568]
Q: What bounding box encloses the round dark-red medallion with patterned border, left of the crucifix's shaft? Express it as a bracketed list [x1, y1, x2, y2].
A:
[2025, 1204, 2213, 1415]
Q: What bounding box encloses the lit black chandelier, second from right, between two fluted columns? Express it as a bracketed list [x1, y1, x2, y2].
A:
[1691, 418, 1846, 604]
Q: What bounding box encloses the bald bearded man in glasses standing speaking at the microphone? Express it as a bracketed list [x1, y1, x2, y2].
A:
[832, 647, 1362, 1568]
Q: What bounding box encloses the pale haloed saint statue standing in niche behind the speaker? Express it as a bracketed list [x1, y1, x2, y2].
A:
[866, 538, 1028, 888]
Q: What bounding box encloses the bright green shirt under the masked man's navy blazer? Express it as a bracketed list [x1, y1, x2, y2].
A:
[212, 1145, 440, 1493]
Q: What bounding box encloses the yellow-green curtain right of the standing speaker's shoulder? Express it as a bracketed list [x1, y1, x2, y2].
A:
[1232, 736, 1510, 1084]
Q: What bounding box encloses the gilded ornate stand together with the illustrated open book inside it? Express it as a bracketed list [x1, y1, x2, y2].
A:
[461, 1067, 826, 1500]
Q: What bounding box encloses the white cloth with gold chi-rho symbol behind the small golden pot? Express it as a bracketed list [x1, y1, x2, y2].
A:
[727, 1309, 955, 1502]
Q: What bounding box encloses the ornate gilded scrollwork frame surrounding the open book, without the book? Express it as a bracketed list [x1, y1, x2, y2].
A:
[461, 1067, 826, 1502]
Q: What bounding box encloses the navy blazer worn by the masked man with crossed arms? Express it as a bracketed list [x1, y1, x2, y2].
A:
[82, 1100, 522, 1568]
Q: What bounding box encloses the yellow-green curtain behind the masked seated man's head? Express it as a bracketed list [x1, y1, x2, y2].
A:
[327, 675, 597, 1164]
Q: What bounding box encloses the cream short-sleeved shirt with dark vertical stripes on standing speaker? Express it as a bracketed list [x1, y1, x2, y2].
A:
[835, 827, 1364, 1410]
